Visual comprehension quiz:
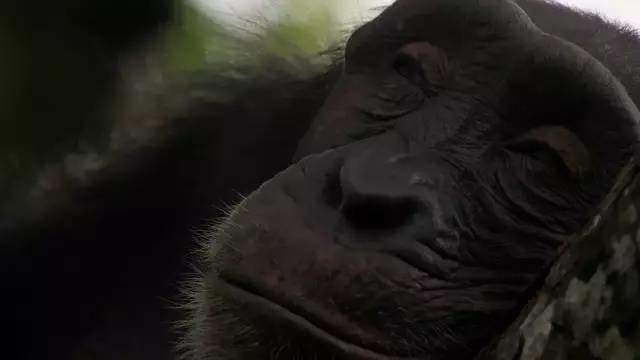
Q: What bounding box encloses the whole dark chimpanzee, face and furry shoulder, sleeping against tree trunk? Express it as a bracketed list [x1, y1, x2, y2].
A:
[0, 0, 640, 360]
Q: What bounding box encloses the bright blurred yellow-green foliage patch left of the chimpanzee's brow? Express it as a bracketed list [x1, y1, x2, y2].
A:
[162, 0, 348, 75]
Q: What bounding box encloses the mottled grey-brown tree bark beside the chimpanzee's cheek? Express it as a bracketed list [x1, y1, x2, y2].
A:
[477, 165, 640, 360]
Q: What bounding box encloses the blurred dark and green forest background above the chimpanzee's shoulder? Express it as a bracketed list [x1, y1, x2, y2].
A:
[0, 0, 362, 213]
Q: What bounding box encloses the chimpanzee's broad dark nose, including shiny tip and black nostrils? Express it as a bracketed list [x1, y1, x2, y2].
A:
[340, 134, 424, 230]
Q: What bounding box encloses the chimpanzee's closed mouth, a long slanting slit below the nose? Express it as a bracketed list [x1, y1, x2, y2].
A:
[217, 277, 418, 360]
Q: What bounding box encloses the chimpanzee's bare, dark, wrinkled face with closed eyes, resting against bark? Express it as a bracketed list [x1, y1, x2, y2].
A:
[187, 0, 638, 360]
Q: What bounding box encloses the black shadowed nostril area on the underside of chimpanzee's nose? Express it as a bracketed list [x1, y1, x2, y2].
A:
[341, 195, 419, 230]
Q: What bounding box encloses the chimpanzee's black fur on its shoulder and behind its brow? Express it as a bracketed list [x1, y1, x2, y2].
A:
[5, 0, 640, 359]
